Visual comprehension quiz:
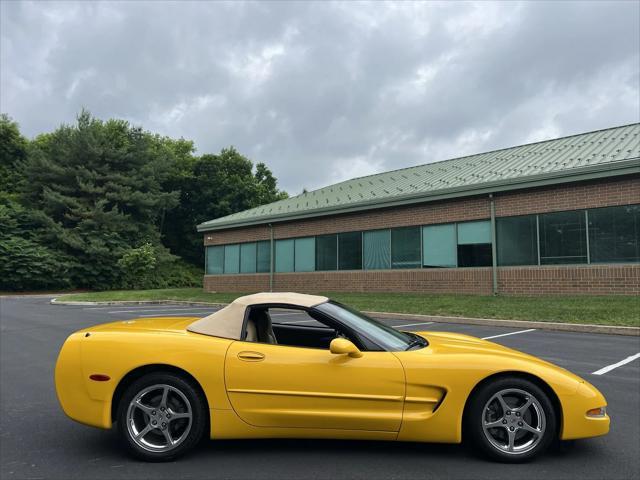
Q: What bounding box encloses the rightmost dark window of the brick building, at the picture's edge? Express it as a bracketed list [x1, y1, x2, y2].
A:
[588, 205, 640, 263]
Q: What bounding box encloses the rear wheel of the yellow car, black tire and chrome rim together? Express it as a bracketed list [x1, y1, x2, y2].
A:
[116, 372, 209, 462]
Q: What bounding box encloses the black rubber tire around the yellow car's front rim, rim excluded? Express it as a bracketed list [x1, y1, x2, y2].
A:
[464, 377, 558, 463]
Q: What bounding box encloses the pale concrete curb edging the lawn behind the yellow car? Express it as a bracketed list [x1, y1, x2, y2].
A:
[50, 298, 640, 337]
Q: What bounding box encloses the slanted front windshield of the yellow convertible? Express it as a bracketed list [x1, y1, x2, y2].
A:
[314, 300, 427, 351]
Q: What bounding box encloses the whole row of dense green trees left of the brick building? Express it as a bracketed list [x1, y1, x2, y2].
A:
[0, 111, 287, 291]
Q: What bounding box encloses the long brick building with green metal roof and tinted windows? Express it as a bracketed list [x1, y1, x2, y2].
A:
[198, 124, 640, 295]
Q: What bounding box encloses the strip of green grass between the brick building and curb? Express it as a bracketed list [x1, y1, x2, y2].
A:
[59, 288, 640, 327]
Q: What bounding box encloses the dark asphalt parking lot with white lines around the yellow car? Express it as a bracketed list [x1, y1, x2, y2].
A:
[0, 297, 640, 479]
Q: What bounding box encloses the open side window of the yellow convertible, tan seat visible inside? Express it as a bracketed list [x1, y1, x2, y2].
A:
[245, 305, 341, 350]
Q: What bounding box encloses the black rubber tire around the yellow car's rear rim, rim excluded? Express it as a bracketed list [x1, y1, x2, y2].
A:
[116, 373, 208, 462]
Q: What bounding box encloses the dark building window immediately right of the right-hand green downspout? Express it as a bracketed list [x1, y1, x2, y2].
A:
[496, 215, 538, 266]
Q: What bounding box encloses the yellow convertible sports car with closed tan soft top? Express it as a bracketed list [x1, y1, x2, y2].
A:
[55, 293, 609, 462]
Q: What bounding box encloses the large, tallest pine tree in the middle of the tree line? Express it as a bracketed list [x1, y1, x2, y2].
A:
[22, 111, 178, 288]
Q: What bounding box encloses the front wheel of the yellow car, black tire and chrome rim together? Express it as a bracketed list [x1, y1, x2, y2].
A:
[463, 377, 558, 463]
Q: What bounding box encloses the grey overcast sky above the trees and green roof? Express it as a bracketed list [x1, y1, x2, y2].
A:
[0, 0, 640, 194]
